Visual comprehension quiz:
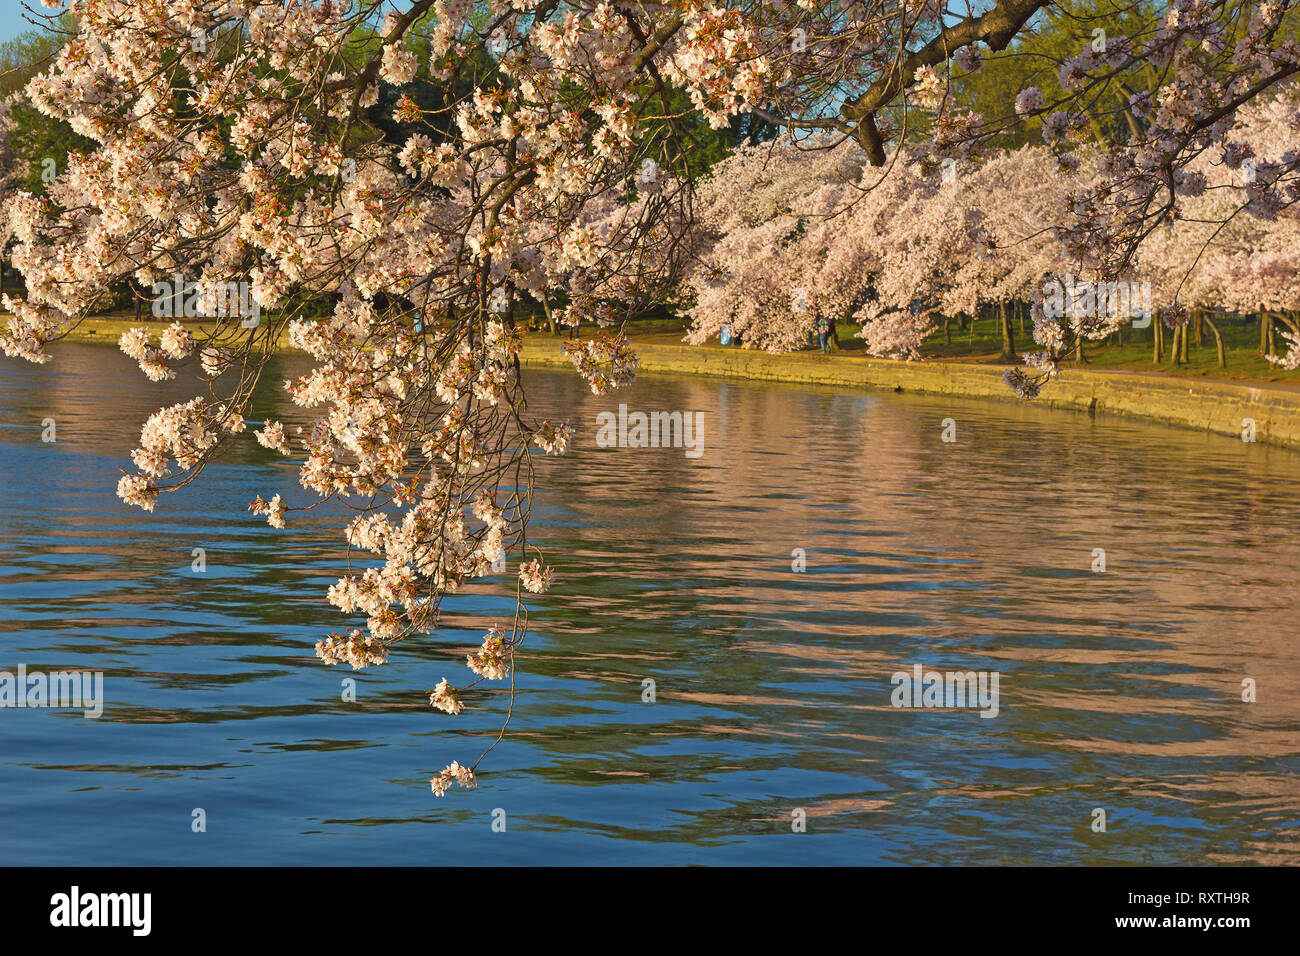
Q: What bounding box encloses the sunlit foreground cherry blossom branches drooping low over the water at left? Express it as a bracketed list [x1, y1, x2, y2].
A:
[10, 0, 1055, 793]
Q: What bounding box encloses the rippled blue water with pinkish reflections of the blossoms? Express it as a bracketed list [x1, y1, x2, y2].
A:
[0, 345, 1300, 865]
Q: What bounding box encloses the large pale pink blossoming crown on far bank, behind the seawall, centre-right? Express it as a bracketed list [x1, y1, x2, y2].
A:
[688, 142, 1069, 359]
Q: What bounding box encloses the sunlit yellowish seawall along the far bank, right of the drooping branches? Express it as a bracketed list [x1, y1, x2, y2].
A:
[520, 336, 1300, 447]
